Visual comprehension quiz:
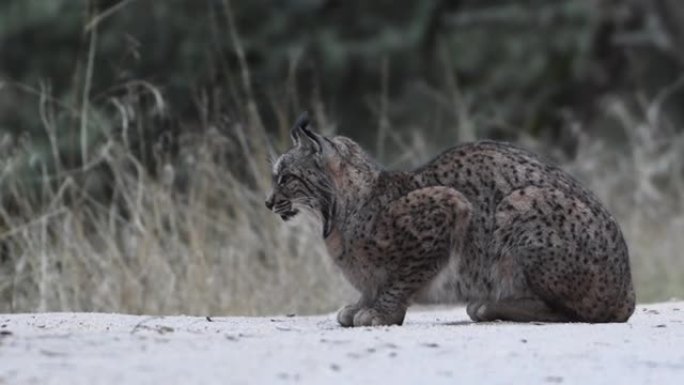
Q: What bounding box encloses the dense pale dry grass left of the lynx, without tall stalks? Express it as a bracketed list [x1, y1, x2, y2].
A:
[0, 112, 348, 314]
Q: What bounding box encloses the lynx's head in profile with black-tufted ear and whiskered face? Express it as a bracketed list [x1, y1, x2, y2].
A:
[266, 112, 340, 233]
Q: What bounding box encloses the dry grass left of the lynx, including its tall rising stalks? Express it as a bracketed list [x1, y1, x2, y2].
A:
[0, 0, 358, 314]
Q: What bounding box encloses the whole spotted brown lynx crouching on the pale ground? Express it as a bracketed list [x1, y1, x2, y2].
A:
[266, 114, 635, 326]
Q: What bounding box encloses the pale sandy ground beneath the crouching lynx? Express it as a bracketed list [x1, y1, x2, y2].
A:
[0, 302, 684, 385]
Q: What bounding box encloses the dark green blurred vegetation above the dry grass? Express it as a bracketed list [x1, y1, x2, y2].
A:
[8, 0, 684, 150]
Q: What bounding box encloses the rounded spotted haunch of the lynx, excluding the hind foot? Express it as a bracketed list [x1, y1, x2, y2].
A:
[495, 187, 633, 322]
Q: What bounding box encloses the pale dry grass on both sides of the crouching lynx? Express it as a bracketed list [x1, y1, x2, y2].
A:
[0, 89, 684, 314]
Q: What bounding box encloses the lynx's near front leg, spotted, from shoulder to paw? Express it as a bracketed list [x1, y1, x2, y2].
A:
[354, 187, 471, 326]
